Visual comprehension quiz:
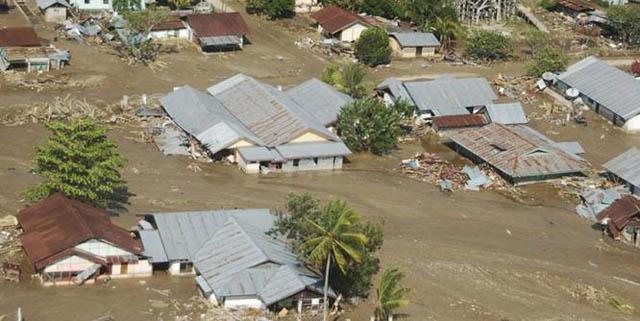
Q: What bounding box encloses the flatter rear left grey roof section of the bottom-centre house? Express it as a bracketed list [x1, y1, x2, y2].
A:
[145, 209, 274, 261]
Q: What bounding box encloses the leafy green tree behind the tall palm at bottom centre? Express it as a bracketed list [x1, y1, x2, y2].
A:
[271, 193, 384, 297]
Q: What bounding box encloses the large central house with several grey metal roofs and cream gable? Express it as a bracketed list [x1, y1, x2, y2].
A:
[160, 74, 351, 173]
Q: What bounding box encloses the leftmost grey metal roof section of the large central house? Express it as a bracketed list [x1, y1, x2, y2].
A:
[160, 86, 262, 153]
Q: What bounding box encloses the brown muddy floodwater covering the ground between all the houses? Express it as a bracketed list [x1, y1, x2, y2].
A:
[0, 1, 640, 321]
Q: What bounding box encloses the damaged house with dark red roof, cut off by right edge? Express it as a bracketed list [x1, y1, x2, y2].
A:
[596, 196, 640, 247]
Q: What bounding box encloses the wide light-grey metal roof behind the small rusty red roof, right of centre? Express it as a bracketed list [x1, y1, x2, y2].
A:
[382, 75, 498, 115]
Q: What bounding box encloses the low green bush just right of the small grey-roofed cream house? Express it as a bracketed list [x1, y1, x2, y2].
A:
[467, 30, 513, 60]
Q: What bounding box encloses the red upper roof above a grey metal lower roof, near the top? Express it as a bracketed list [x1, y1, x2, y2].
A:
[187, 12, 249, 37]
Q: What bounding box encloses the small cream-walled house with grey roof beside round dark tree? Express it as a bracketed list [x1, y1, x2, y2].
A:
[389, 32, 440, 58]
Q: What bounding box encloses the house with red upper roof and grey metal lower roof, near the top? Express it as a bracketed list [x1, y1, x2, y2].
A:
[186, 12, 249, 52]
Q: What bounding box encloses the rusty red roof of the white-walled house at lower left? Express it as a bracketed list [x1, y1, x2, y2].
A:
[18, 193, 143, 269]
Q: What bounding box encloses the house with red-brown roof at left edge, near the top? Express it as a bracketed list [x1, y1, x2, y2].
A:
[0, 27, 70, 72]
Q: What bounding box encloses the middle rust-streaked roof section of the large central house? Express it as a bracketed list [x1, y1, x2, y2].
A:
[208, 74, 339, 146]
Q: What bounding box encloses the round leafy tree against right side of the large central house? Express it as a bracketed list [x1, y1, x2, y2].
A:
[337, 98, 403, 155]
